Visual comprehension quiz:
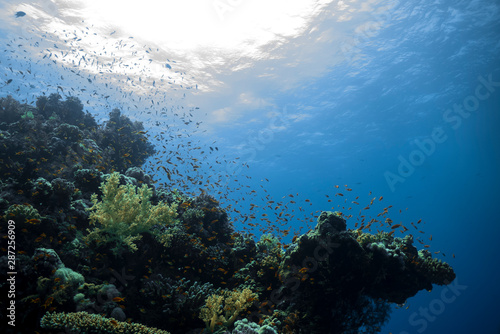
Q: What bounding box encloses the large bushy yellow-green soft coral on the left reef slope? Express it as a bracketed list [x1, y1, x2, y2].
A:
[85, 172, 177, 254]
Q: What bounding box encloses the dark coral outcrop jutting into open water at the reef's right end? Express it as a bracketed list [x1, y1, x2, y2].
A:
[275, 212, 455, 333]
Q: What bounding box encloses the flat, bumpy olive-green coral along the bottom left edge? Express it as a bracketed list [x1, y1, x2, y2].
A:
[40, 312, 170, 334]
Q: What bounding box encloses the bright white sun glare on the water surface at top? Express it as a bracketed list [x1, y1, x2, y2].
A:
[81, 0, 325, 51]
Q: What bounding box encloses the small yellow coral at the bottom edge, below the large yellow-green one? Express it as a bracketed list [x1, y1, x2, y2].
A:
[200, 289, 257, 332]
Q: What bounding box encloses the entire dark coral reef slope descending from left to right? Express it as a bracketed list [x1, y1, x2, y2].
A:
[0, 94, 455, 334]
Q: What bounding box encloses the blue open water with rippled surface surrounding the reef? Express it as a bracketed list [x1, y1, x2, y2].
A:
[0, 0, 500, 334]
